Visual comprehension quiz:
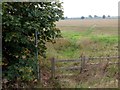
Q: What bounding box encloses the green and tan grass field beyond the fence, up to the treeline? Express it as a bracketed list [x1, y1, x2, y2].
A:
[48, 19, 118, 59]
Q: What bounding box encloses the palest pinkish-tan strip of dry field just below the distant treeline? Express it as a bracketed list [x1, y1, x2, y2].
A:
[56, 19, 118, 27]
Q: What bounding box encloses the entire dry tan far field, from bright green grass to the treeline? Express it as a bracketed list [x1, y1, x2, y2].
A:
[56, 19, 118, 35]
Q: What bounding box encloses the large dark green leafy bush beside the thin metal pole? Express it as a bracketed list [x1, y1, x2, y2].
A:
[2, 1, 63, 81]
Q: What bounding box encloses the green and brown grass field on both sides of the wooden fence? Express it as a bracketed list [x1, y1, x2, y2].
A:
[40, 19, 118, 88]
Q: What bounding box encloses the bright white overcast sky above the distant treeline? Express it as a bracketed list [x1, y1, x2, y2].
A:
[61, 0, 120, 17]
